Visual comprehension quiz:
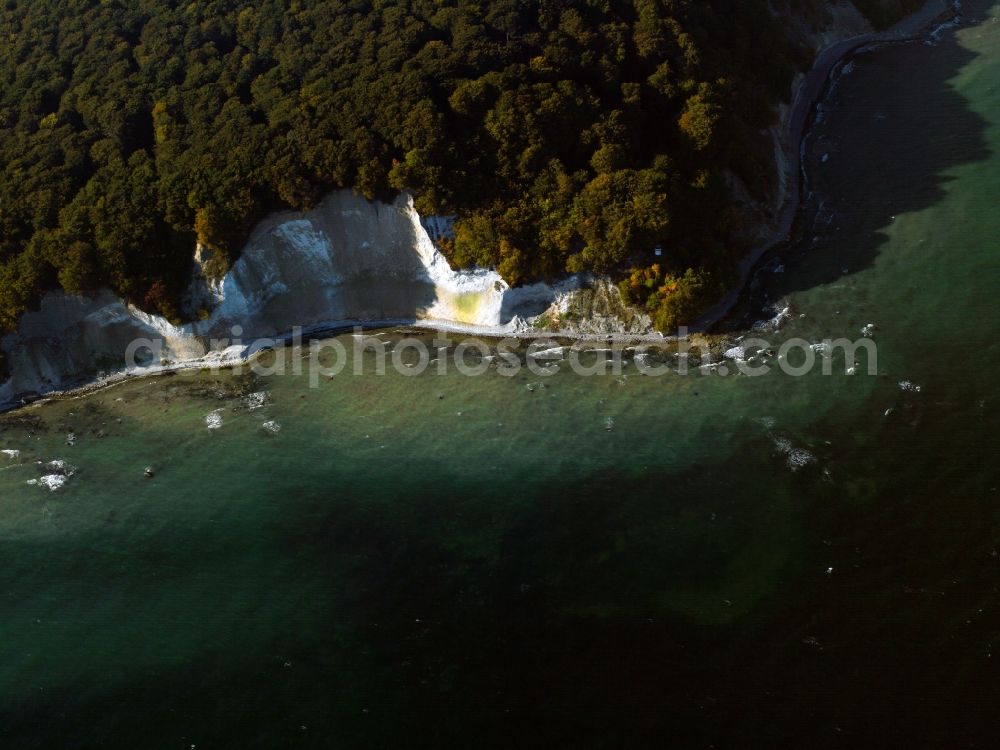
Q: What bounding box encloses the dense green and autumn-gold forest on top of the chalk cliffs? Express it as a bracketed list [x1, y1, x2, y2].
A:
[0, 0, 920, 340]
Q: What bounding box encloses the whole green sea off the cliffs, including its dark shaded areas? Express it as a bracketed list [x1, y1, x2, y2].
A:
[0, 8, 1000, 748]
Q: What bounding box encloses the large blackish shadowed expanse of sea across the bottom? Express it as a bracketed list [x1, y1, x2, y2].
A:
[0, 428, 995, 750]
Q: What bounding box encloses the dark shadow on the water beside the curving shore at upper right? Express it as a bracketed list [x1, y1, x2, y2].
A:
[718, 21, 991, 332]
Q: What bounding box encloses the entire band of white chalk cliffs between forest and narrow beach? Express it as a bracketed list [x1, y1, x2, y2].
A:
[0, 190, 650, 404]
